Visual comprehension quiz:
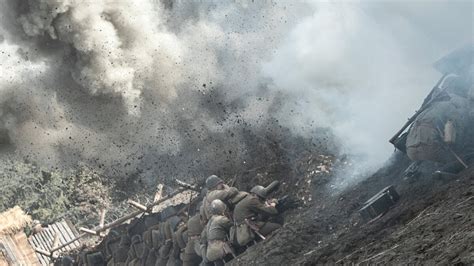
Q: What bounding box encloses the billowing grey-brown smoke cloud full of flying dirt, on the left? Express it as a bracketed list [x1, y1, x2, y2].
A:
[0, 0, 305, 185]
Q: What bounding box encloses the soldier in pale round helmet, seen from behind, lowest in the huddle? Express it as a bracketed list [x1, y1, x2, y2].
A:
[201, 199, 233, 265]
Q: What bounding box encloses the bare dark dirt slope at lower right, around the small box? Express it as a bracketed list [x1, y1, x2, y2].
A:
[230, 154, 474, 265]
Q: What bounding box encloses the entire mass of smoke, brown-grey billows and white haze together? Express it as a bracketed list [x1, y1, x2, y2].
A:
[0, 0, 472, 192]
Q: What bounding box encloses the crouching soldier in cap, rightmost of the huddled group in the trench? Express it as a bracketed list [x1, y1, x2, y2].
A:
[234, 186, 281, 246]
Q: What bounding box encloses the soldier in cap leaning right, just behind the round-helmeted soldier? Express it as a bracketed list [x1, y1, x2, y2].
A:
[200, 175, 239, 225]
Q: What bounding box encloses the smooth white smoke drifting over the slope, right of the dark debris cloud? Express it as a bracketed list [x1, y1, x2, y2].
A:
[264, 1, 474, 189]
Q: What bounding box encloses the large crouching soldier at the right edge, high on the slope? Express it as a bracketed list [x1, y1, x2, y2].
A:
[392, 46, 474, 172]
